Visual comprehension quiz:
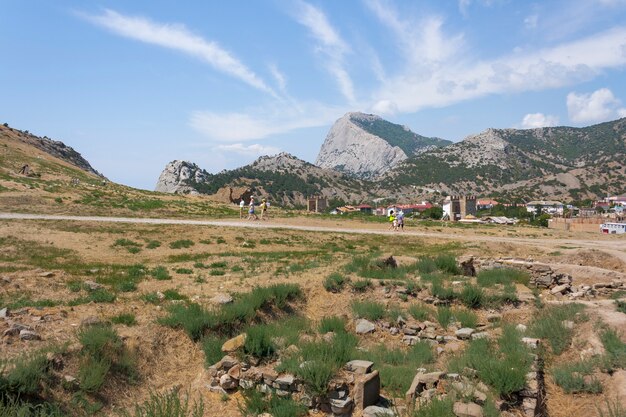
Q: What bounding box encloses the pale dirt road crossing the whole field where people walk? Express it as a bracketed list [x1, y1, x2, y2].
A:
[0, 212, 626, 256]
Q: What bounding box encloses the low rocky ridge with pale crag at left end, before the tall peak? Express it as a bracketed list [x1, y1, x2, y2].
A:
[156, 153, 373, 206]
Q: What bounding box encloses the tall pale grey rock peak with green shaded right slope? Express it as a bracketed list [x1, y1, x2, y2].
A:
[315, 113, 452, 179]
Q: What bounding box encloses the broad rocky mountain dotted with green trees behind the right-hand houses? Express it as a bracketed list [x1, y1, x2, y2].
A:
[380, 119, 626, 200]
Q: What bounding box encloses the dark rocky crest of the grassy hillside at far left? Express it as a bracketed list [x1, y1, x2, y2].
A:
[0, 124, 102, 177]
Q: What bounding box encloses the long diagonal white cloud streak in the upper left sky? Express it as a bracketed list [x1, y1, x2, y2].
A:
[78, 9, 276, 96]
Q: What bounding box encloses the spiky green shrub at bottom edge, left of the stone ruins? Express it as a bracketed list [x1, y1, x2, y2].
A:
[122, 392, 204, 417]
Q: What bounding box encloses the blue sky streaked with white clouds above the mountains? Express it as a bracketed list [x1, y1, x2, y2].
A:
[0, 0, 626, 189]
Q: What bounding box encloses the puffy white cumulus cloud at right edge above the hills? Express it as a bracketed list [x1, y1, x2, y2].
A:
[567, 88, 626, 123]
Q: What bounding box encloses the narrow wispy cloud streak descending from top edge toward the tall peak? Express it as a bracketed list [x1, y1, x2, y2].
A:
[295, 1, 356, 103]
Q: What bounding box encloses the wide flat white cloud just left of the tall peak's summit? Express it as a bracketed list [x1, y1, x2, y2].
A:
[190, 102, 350, 142]
